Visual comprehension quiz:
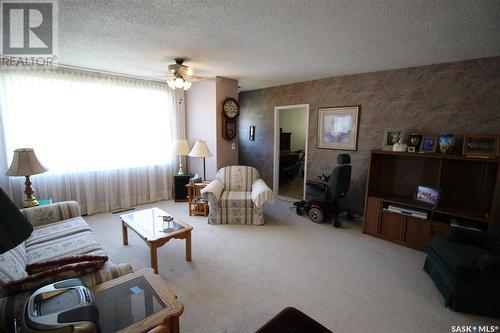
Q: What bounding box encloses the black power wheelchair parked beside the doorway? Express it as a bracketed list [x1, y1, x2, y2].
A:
[306, 154, 352, 227]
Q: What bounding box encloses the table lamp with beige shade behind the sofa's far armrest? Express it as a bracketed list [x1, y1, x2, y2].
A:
[5, 148, 48, 207]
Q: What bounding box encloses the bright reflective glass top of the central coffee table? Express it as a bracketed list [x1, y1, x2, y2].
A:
[120, 207, 185, 240]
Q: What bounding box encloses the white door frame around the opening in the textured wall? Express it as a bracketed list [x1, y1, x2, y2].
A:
[273, 104, 309, 200]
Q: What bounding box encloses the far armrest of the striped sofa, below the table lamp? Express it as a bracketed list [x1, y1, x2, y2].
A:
[21, 201, 81, 227]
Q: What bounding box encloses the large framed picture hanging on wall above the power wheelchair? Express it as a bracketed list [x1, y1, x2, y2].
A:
[318, 106, 359, 150]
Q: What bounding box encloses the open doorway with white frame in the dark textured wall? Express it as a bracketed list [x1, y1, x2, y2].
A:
[273, 104, 309, 200]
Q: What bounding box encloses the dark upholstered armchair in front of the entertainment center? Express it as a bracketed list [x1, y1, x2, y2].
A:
[424, 227, 500, 318]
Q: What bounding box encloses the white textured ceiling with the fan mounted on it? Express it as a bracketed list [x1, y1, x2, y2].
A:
[58, 0, 500, 90]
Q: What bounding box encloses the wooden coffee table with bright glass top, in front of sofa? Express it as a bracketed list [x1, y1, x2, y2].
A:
[120, 207, 193, 274]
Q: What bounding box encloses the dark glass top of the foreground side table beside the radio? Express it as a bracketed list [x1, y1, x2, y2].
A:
[94, 276, 165, 333]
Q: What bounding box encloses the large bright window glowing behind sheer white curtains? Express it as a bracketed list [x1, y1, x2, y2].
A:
[0, 71, 174, 173]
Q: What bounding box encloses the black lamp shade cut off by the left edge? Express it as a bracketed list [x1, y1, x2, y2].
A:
[0, 188, 33, 254]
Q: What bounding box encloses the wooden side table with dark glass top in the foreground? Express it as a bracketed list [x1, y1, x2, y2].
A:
[91, 268, 184, 333]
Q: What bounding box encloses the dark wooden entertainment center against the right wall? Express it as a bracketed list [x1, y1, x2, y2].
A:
[363, 150, 500, 251]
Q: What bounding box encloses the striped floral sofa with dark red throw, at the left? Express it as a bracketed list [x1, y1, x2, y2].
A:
[0, 201, 133, 332]
